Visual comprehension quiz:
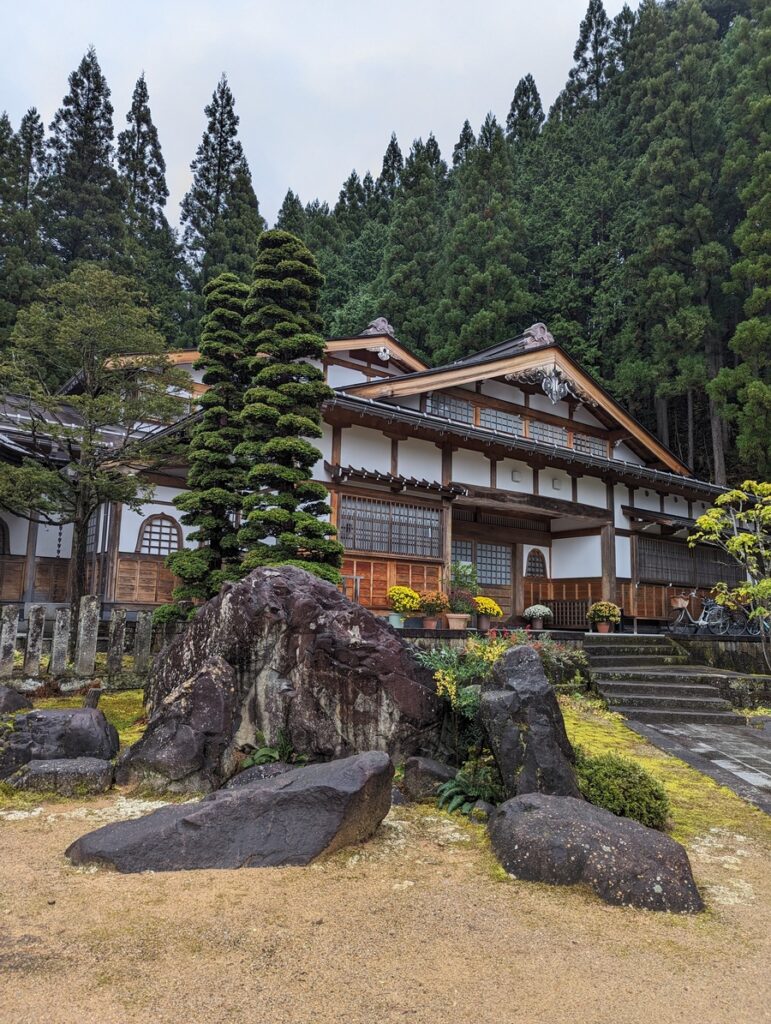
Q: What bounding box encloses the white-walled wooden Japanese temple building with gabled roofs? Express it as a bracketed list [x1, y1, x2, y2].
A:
[0, 319, 736, 630]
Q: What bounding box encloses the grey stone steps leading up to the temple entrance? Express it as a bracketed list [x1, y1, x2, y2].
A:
[584, 633, 744, 725]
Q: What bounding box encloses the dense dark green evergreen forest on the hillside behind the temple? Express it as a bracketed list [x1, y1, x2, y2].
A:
[0, 0, 771, 483]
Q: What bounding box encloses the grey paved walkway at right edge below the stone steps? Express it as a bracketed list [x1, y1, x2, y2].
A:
[627, 719, 771, 814]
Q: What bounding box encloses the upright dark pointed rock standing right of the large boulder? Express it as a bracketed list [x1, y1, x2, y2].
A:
[479, 647, 581, 797]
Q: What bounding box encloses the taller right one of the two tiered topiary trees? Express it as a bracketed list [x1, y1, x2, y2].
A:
[235, 230, 343, 583]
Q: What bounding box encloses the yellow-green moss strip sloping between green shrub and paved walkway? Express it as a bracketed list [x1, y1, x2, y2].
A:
[559, 696, 771, 846]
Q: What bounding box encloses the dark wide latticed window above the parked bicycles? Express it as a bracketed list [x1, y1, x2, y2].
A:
[637, 536, 744, 588]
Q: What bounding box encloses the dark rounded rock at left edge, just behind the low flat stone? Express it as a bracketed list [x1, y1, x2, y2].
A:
[0, 708, 119, 779]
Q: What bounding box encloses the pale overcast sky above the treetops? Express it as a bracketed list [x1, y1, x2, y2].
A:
[0, 0, 623, 223]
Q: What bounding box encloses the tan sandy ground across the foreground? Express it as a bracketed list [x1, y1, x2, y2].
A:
[0, 796, 771, 1024]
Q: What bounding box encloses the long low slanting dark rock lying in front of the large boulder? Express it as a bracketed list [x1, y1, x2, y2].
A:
[67, 751, 393, 871]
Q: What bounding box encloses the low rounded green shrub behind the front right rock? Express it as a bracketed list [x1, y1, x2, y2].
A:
[575, 748, 670, 829]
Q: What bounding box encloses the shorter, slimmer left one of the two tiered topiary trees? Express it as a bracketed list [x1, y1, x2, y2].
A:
[168, 273, 249, 601]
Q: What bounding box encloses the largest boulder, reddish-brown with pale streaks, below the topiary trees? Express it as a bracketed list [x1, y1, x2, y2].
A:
[122, 566, 442, 790]
